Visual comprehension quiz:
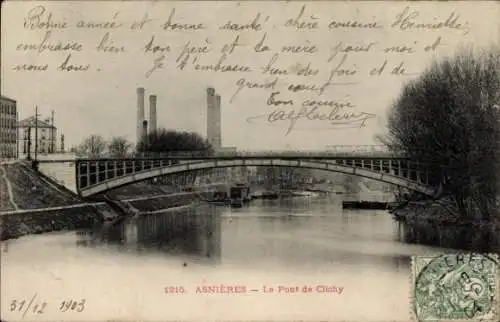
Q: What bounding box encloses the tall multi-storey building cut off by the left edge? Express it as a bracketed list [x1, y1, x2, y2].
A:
[0, 96, 18, 159]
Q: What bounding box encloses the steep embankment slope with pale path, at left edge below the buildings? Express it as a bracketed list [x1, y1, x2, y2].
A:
[0, 161, 118, 240]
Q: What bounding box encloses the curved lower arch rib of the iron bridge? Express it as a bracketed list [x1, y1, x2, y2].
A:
[77, 159, 435, 197]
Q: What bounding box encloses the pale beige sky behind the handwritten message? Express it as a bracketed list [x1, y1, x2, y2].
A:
[1, 1, 500, 151]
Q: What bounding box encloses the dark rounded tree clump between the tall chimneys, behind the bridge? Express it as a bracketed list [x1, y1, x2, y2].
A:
[137, 129, 213, 155]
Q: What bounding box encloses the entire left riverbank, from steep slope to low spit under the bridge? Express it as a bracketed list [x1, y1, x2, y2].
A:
[0, 161, 213, 240]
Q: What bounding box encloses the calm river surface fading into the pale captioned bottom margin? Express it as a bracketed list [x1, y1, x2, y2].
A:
[1, 196, 451, 321]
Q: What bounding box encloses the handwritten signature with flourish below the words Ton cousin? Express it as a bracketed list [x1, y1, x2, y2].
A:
[247, 106, 376, 136]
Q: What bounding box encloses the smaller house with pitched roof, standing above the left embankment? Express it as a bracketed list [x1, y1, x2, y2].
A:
[18, 116, 58, 157]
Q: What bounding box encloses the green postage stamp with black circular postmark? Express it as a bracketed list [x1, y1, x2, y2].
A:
[411, 253, 500, 321]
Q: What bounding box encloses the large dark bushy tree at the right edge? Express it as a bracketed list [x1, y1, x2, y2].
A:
[382, 48, 500, 219]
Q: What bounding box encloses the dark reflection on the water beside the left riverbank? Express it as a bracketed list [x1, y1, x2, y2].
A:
[76, 205, 221, 261]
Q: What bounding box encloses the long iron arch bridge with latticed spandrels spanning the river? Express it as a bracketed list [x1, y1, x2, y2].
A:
[75, 154, 436, 197]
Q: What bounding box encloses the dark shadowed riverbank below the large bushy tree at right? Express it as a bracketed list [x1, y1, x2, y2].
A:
[391, 201, 500, 253]
